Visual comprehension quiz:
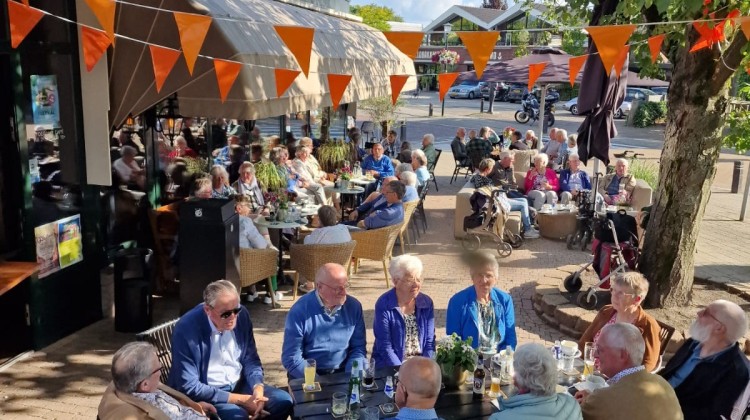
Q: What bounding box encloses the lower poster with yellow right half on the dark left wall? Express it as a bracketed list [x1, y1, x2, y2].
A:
[34, 214, 83, 278]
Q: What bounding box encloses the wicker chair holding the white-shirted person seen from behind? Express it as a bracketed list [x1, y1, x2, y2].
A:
[289, 241, 357, 299]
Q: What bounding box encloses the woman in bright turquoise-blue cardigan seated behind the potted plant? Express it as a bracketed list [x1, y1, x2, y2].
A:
[445, 251, 516, 353]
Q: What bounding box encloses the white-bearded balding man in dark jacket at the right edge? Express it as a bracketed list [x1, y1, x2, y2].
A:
[659, 299, 750, 420]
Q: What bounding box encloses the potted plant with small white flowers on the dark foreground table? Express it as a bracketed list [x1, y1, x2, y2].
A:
[435, 333, 477, 389]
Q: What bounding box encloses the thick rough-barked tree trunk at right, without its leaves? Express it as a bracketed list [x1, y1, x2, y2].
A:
[640, 43, 728, 307]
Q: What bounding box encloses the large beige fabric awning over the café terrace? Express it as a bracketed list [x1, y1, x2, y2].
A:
[109, 0, 416, 126]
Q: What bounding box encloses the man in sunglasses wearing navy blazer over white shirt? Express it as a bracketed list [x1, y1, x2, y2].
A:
[168, 280, 292, 420]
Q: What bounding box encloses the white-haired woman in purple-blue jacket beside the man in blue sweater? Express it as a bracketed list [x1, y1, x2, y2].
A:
[372, 255, 435, 367]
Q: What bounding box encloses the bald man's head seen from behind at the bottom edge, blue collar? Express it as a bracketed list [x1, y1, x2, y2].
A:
[395, 356, 440, 420]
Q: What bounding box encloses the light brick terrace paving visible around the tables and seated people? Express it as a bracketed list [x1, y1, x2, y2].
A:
[0, 145, 750, 419]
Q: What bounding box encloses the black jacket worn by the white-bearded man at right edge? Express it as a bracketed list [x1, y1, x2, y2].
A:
[659, 339, 750, 420]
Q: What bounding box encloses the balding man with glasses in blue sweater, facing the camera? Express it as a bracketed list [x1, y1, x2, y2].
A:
[281, 263, 367, 379]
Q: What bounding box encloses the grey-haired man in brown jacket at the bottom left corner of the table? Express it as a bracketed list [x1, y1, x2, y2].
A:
[97, 341, 216, 420]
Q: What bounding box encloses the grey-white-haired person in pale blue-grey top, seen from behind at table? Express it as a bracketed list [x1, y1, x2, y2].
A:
[490, 343, 583, 420]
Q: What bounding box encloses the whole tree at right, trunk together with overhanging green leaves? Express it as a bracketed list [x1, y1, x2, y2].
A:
[545, 0, 750, 307]
